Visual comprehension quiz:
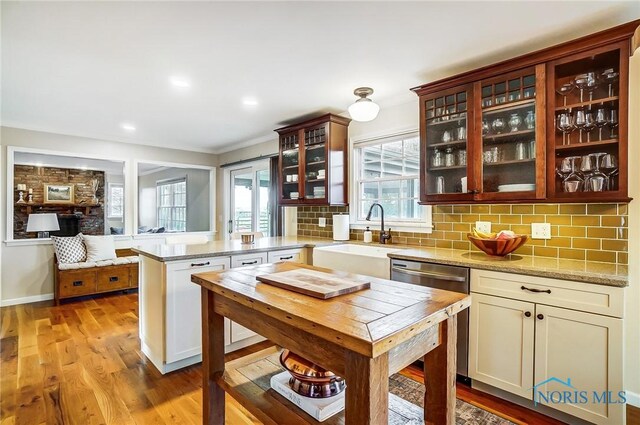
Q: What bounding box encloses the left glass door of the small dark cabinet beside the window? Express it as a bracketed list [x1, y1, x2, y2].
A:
[280, 131, 302, 204]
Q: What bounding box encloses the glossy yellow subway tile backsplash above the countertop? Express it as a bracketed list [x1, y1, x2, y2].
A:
[298, 204, 628, 264]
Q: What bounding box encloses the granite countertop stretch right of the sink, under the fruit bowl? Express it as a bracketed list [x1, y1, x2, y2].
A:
[388, 247, 629, 287]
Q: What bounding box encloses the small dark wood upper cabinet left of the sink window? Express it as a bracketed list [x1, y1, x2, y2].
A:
[275, 114, 351, 205]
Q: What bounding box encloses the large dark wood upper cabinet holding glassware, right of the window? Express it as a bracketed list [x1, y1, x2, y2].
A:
[412, 21, 640, 204]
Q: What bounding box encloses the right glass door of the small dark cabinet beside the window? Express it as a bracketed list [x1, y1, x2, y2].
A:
[304, 123, 328, 203]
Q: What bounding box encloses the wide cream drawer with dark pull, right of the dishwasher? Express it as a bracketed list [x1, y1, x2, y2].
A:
[471, 269, 624, 317]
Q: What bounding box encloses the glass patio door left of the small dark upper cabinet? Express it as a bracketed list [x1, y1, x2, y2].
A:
[227, 161, 271, 236]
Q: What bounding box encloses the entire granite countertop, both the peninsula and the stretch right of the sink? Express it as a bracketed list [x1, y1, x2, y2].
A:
[133, 236, 629, 287]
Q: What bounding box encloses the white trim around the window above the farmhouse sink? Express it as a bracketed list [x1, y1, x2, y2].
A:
[349, 128, 433, 233]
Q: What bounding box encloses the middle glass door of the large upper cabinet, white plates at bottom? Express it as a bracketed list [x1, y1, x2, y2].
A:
[475, 65, 546, 200]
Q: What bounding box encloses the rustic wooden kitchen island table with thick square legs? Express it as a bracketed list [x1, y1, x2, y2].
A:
[192, 263, 471, 425]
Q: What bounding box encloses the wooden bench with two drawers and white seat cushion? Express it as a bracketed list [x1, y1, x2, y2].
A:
[54, 249, 138, 305]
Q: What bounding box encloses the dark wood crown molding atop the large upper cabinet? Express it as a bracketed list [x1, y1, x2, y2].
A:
[411, 20, 640, 95]
